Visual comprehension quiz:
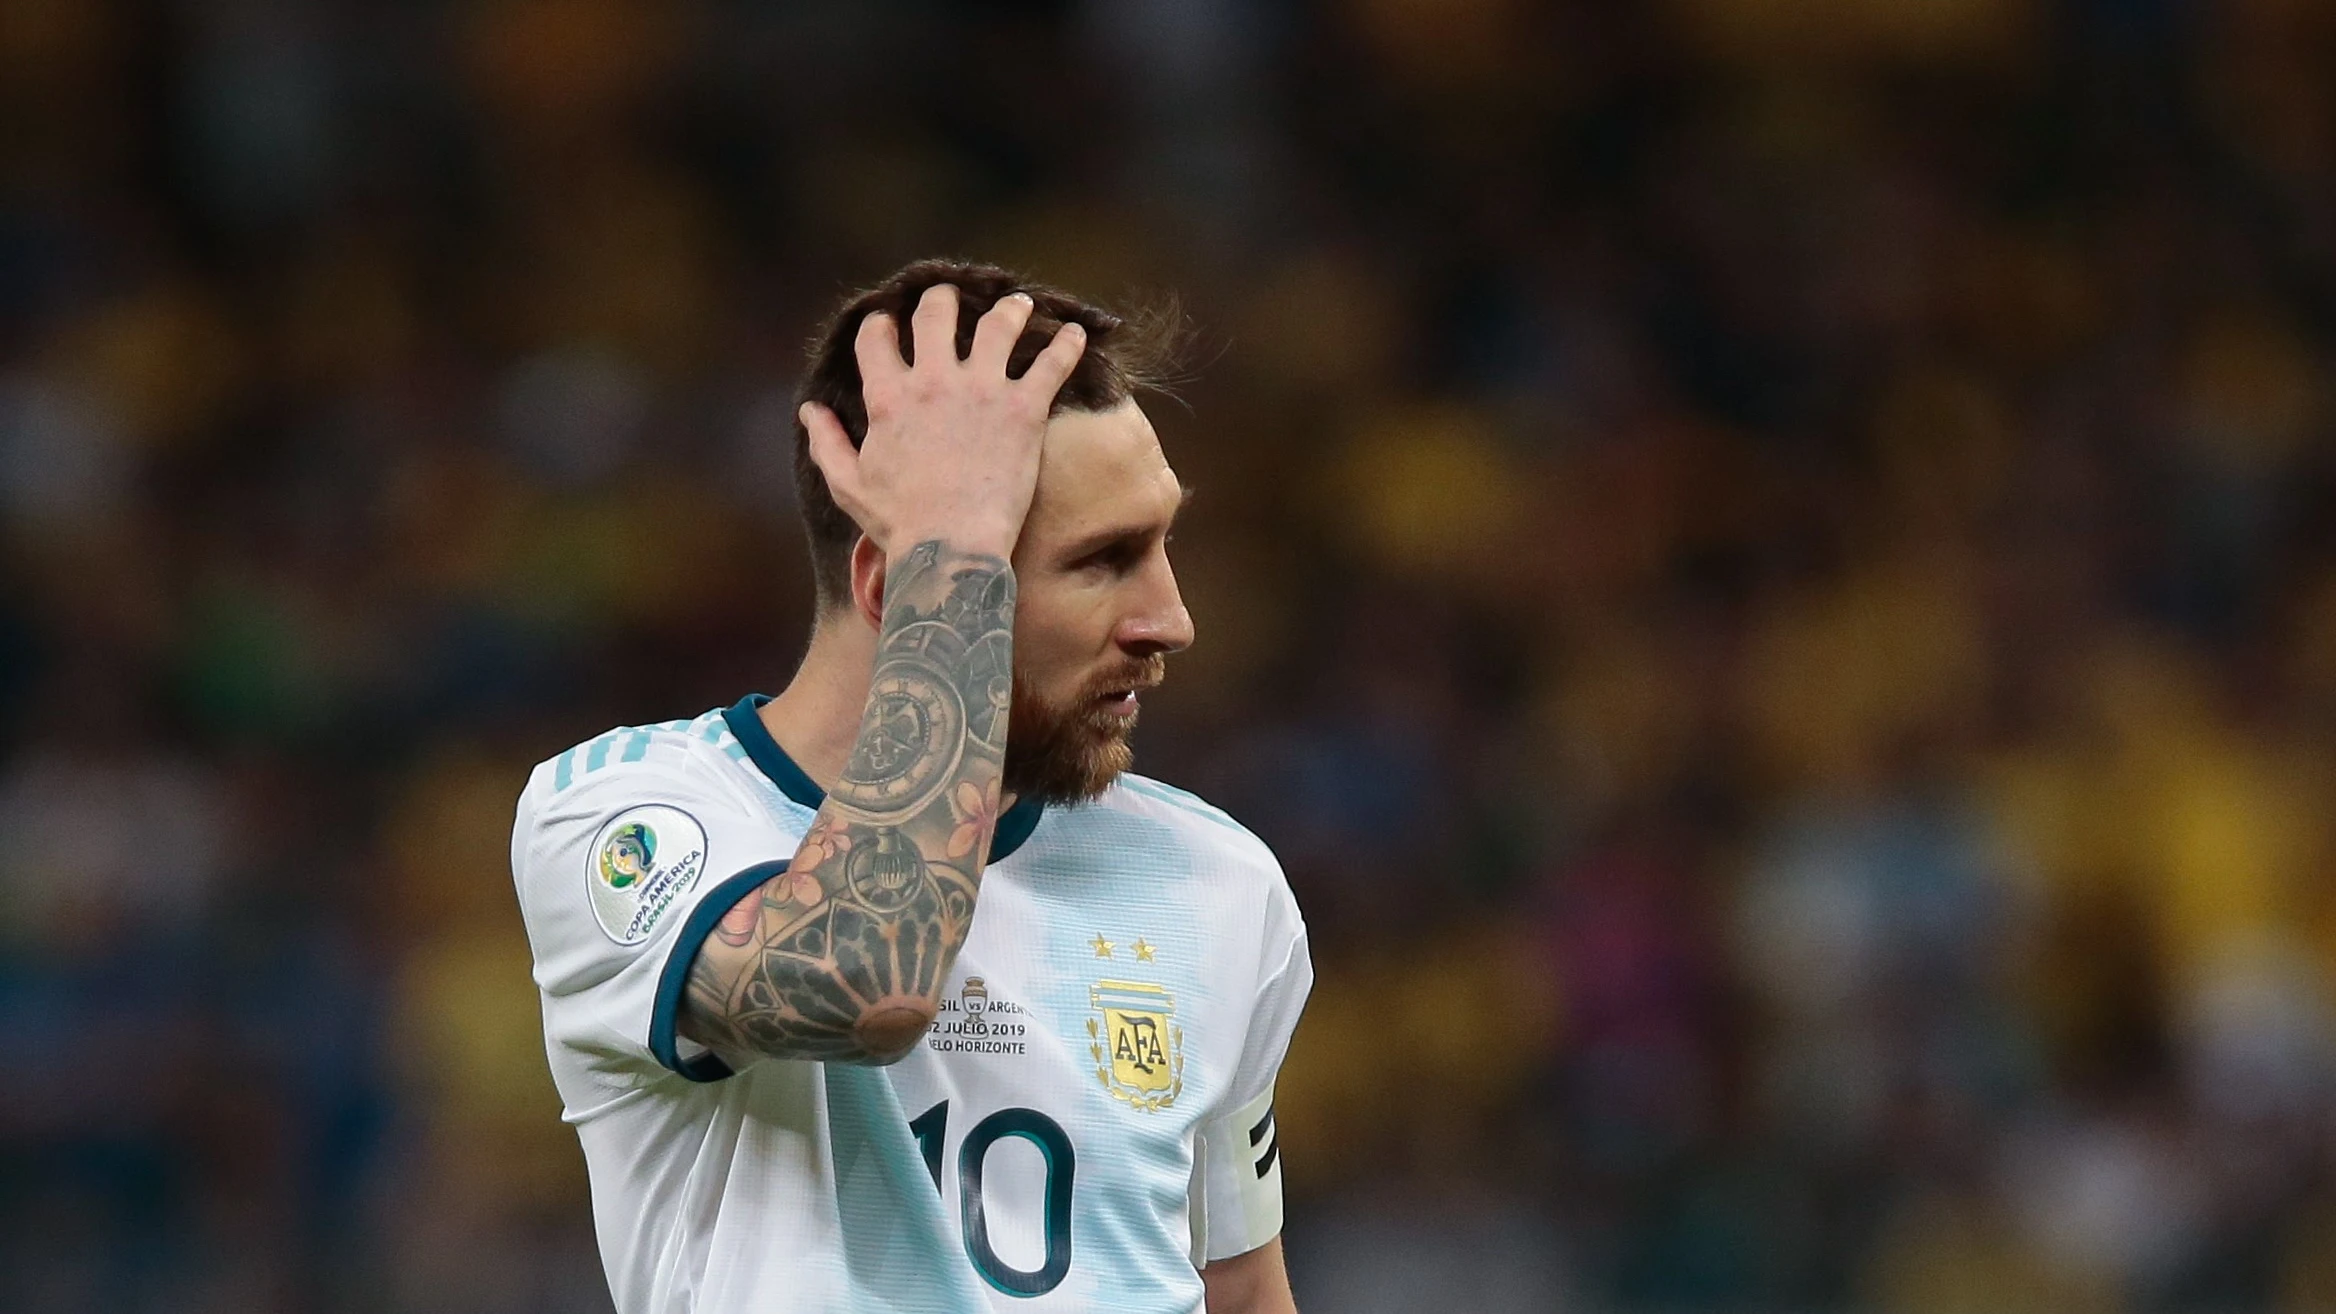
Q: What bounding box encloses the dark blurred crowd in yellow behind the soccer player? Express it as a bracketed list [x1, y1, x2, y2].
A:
[0, 0, 2336, 1314]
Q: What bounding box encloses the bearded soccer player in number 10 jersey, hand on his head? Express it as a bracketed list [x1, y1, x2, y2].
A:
[512, 262, 1313, 1314]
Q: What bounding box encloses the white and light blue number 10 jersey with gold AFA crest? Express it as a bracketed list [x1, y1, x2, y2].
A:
[512, 697, 1313, 1314]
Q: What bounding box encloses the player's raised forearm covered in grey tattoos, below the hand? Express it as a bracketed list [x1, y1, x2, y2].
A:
[682, 540, 1014, 1064]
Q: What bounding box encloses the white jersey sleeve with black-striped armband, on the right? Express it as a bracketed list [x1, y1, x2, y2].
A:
[1191, 870, 1313, 1265]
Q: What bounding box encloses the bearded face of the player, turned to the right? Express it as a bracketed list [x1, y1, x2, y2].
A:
[1004, 392, 1191, 802]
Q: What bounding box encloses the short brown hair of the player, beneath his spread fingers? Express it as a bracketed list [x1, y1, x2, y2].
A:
[794, 260, 1184, 608]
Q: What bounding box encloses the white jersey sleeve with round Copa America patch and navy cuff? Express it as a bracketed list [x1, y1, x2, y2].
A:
[512, 753, 799, 1089]
